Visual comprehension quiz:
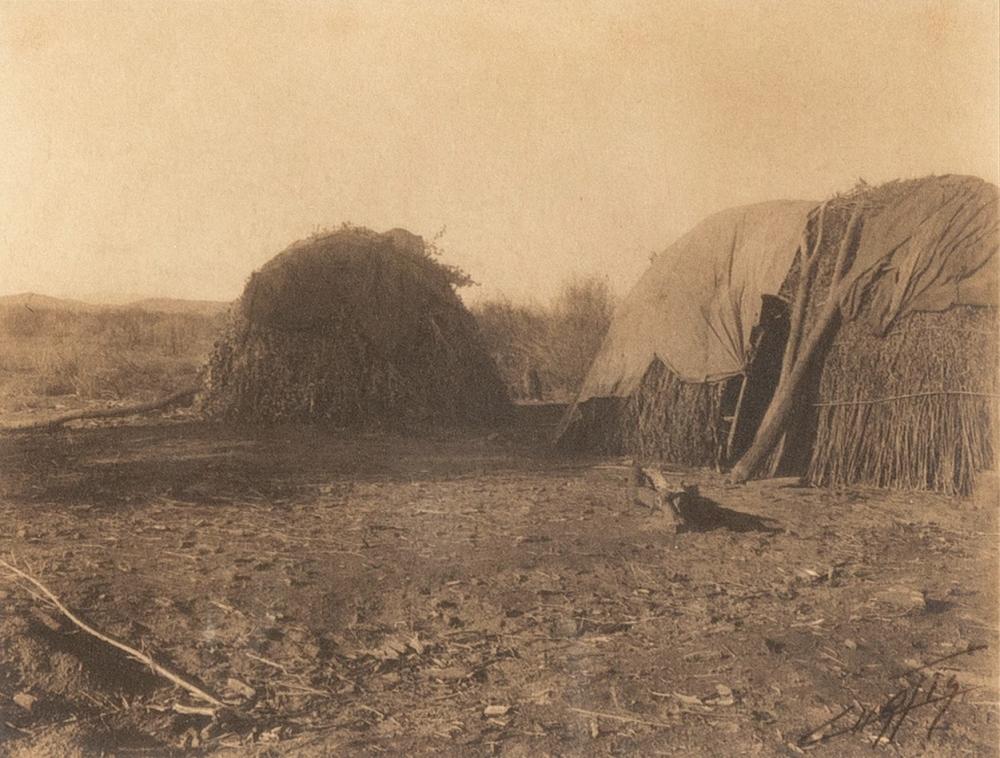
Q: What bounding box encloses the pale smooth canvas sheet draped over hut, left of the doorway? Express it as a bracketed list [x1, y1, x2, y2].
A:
[578, 200, 817, 402]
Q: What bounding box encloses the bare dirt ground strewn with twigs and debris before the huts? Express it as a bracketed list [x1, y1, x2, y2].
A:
[0, 407, 998, 756]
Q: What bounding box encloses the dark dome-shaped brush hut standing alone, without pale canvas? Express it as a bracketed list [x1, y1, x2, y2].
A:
[204, 227, 509, 426]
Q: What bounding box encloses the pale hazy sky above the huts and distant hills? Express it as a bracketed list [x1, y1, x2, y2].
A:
[0, 0, 1000, 300]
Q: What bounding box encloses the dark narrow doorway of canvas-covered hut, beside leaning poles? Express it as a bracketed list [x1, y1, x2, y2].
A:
[721, 295, 789, 465]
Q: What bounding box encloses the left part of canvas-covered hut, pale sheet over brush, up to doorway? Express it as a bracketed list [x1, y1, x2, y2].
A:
[559, 201, 816, 466]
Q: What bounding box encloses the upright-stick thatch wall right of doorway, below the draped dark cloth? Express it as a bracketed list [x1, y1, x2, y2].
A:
[808, 306, 1000, 494]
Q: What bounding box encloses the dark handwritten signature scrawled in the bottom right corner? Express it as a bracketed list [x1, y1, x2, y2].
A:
[796, 645, 987, 748]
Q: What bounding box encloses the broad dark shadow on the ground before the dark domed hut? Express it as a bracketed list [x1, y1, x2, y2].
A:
[0, 405, 586, 506]
